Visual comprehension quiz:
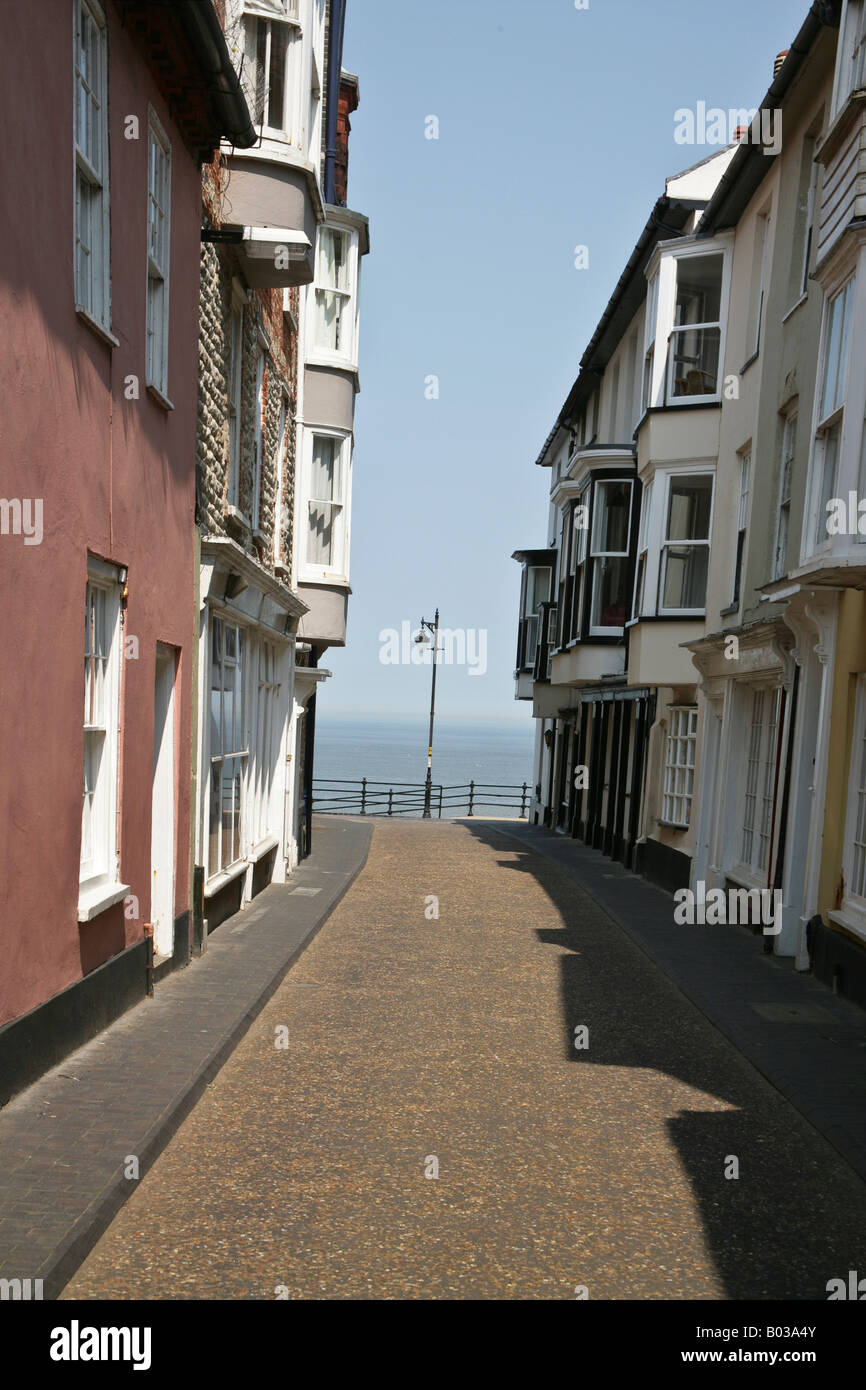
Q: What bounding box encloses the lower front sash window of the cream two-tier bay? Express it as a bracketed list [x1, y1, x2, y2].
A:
[659, 473, 713, 614]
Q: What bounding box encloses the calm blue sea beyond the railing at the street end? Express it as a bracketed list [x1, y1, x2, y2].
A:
[316, 710, 535, 816]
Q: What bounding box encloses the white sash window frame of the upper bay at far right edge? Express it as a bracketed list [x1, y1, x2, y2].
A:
[801, 268, 858, 563]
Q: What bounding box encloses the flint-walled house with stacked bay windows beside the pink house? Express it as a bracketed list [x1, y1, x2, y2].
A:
[195, 0, 368, 931]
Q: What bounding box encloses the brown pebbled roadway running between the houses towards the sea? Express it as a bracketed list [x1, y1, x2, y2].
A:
[63, 821, 866, 1300]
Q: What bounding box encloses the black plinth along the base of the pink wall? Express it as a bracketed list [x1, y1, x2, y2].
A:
[0, 941, 147, 1105]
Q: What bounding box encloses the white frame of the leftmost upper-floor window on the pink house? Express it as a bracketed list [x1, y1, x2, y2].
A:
[72, 0, 111, 335]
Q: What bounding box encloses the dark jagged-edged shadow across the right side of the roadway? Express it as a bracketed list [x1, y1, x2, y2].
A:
[461, 820, 866, 1300]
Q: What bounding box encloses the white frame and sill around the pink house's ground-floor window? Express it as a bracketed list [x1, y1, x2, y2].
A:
[79, 557, 122, 920]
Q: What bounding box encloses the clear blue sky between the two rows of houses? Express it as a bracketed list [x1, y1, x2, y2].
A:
[320, 0, 809, 720]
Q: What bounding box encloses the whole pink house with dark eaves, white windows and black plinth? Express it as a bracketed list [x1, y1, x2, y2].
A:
[0, 0, 256, 1098]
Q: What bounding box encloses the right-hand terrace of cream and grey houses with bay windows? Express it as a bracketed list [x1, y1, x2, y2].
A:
[517, 0, 866, 1002]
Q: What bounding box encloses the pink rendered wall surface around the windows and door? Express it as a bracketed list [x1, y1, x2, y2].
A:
[0, 0, 202, 1023]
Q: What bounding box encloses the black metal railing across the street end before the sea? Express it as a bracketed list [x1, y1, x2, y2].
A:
[313, 777, 530, 820]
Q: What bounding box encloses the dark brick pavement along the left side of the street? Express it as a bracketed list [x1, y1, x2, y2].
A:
[0, 820, 371, 1298]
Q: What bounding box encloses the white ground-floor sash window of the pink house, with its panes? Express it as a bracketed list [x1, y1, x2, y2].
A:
[79, 560, 121, 915]
